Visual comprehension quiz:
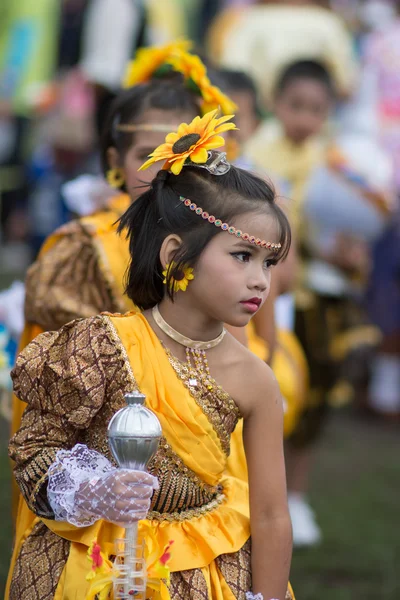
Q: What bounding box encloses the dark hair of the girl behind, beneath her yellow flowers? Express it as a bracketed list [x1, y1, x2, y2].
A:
[100, 73, 201, 174]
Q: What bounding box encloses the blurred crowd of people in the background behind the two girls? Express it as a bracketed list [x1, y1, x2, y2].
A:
[0, 0, 400, 543]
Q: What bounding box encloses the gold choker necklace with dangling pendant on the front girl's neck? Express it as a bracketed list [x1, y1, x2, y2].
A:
[152, 306, 226, 390]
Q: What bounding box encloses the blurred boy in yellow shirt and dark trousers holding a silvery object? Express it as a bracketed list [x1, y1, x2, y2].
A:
[245, 60, 385, 546]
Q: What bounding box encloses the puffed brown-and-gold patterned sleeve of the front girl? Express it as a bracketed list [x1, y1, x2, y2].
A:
[9, 317, 133, 518]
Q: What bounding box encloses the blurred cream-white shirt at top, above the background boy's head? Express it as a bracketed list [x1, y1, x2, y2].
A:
[216, 0, 356, 108]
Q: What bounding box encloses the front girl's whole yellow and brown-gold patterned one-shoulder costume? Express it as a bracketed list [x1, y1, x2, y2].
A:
[7, 314, 291, 600]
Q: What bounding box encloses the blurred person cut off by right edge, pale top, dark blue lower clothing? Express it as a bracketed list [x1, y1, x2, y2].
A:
[362, 0, 400, 417]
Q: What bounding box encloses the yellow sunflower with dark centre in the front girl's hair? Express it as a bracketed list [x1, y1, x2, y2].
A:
[139, 110, 237, 175]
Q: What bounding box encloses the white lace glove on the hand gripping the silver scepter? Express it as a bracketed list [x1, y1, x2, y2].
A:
[47, 444, 158, 527]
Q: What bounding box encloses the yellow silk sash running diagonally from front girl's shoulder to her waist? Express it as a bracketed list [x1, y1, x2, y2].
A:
[109, 314, 250, 571]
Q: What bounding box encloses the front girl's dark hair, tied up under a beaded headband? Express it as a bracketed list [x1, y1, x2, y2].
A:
[119, 166, 291, 310]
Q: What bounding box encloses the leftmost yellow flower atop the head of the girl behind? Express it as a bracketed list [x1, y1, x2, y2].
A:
[122, 40, 192, 88]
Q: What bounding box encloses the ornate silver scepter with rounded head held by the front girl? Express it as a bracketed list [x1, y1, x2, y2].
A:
[108, 392, 162, 600]
